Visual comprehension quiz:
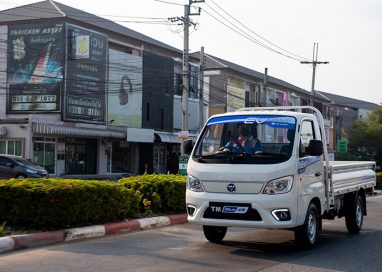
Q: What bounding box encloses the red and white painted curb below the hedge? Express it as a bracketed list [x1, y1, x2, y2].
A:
[0, 214, 188, 253]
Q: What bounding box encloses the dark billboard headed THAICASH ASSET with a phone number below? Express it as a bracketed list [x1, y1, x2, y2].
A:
[7, 23, 65, 113]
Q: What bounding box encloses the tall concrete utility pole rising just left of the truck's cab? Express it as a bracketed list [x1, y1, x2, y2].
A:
[168, 0, 204, 156]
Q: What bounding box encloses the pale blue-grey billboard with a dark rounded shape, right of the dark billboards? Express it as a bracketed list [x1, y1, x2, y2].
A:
[108, 49, 143, 128]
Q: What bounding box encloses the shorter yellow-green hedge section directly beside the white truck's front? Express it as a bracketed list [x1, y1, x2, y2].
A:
[119, 174, 186, 217]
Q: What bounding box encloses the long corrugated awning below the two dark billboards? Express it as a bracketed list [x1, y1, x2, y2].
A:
[33, 123, 126, 139]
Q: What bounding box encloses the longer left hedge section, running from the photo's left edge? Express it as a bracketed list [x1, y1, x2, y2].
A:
[0, 178, 141, 229]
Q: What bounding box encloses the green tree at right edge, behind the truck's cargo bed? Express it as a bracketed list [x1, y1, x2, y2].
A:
[345, 107, 382, 164]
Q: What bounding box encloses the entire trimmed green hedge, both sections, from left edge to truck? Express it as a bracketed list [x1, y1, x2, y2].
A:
[0, 174, 186, 230]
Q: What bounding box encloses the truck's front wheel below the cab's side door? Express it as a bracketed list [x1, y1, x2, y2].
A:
[294, 203, 320, 249]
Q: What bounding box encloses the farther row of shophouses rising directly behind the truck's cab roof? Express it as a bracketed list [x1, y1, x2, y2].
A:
[192, 52, 333, 147]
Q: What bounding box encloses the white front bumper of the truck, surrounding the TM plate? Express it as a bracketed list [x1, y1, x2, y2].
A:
[186, 190, 297, 229]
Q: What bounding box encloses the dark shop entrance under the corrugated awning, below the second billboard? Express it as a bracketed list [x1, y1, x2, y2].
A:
[65, 138, 97, 175]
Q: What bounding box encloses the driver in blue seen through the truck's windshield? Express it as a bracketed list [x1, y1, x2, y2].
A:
[225, 126, 261, 154]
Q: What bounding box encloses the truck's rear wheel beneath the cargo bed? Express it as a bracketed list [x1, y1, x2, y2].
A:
[345, 195, 364, 234]
